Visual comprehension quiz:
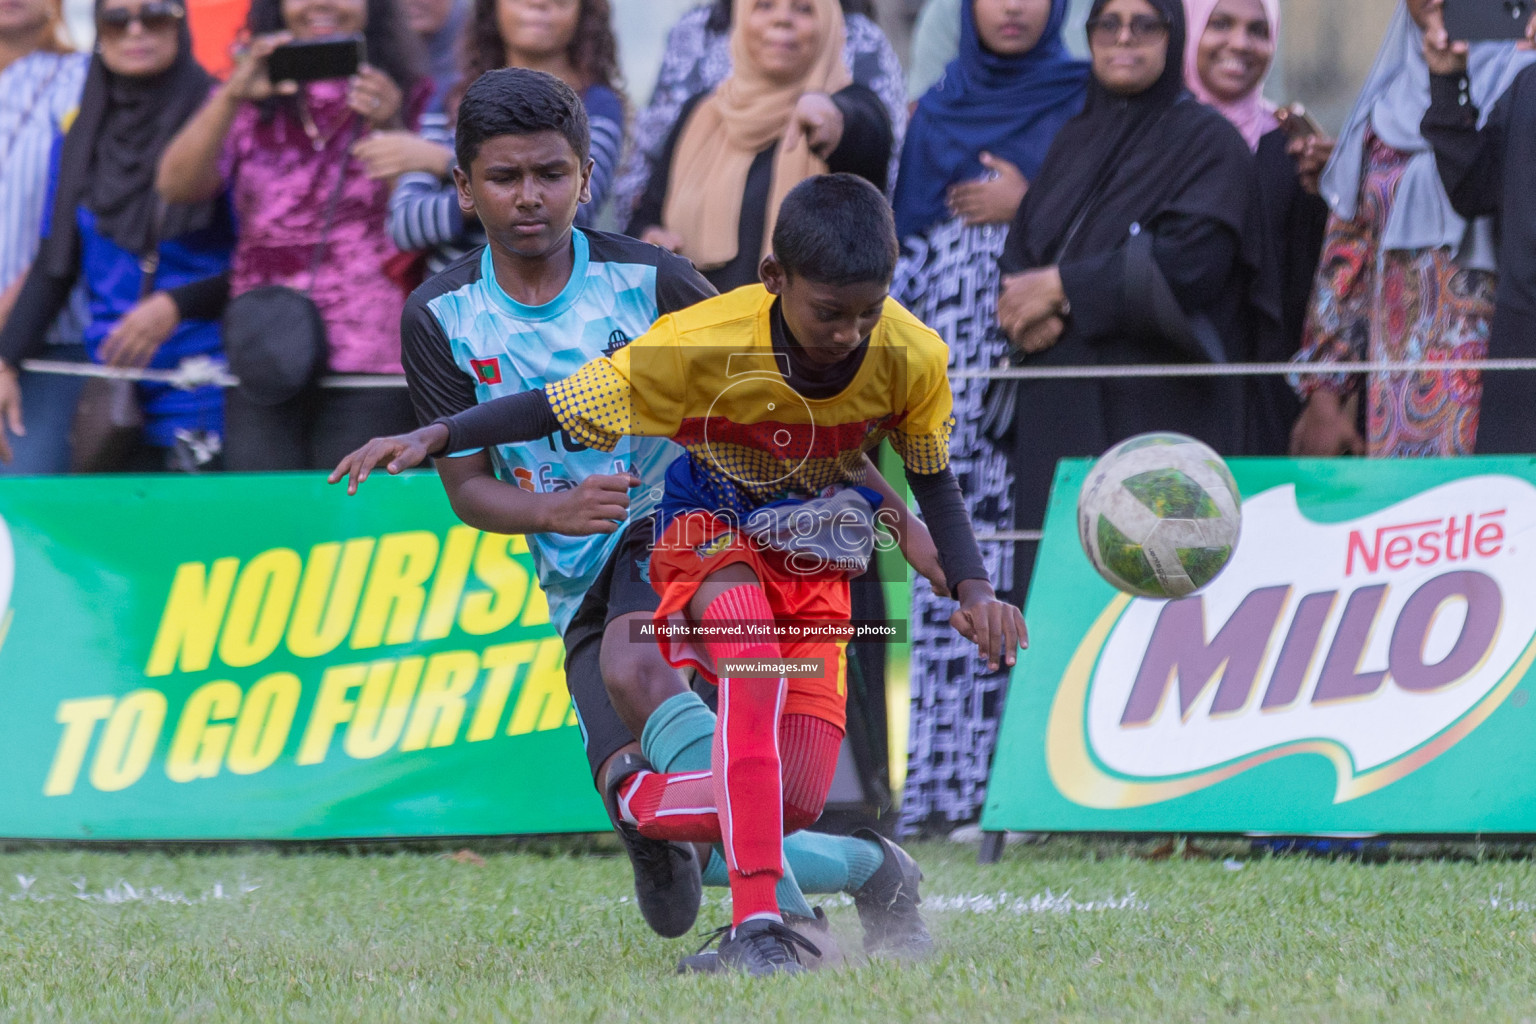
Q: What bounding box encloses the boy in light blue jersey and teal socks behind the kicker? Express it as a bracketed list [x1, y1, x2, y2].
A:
[351, 69, 928, 952]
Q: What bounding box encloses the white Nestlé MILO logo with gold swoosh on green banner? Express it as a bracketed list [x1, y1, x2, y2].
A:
[1046, 474, 1536, 809]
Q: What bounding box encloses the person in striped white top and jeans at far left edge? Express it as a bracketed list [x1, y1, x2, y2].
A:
[0, 0, 89, 474]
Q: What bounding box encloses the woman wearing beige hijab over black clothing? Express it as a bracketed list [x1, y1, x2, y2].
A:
[630, 0, 892, 292]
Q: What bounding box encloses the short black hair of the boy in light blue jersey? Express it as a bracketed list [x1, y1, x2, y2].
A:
[453, 68, 591, 173]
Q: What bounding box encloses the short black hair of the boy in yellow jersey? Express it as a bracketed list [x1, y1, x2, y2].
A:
[773, 173, 900, 286]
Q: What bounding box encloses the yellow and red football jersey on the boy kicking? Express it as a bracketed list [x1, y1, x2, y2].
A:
[545, 284, 954, 508]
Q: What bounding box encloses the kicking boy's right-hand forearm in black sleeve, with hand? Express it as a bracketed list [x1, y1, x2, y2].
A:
[906, 467, 1029, 672]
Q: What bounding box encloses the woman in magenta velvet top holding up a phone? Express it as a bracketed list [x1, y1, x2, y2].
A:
[158, 0, 432, 471]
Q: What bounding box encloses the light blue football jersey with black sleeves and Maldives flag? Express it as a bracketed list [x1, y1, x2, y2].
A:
[401, 229, 714, 633]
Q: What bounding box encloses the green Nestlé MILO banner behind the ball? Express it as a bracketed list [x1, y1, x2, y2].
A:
[983, 459, 1536, 834]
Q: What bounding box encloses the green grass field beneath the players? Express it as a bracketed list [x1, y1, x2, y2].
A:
[0, 840, 1536, 1024]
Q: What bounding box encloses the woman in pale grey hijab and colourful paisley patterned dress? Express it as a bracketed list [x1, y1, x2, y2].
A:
[1290, 0, 1528, 457]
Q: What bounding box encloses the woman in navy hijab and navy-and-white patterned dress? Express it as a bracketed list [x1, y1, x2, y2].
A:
[894, 0, 1087, 834]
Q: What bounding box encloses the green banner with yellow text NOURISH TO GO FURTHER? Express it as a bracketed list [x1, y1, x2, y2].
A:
[0, 474, 607, 840]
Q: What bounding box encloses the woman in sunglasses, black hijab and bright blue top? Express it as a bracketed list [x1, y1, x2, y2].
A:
[0, 0, 233, 471]
